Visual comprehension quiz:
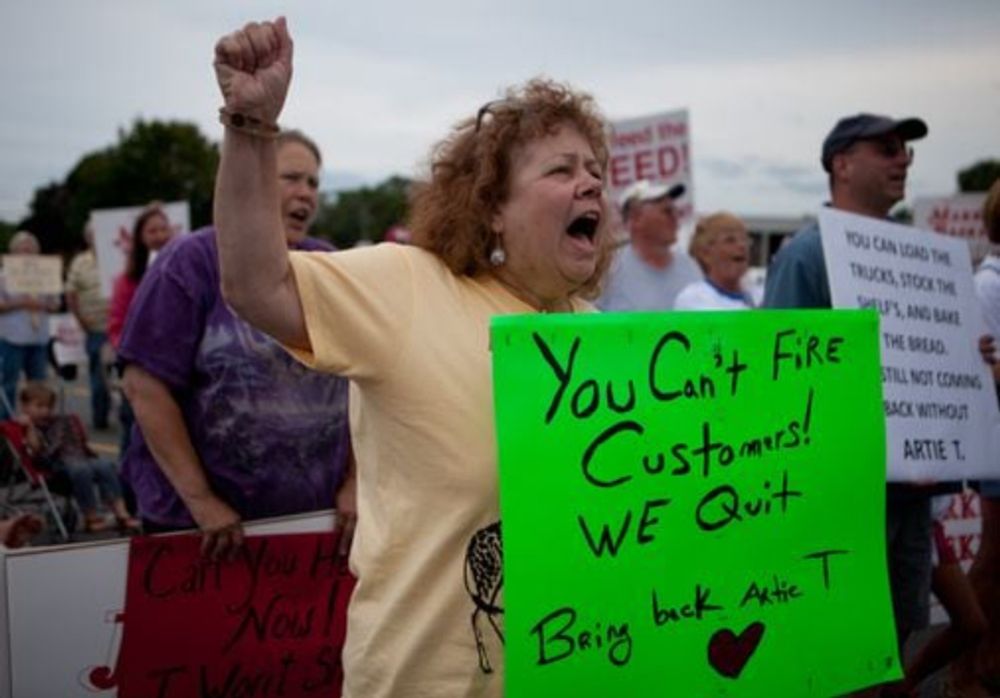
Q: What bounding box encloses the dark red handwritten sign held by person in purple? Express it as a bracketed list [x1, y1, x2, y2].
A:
[115, 533, 355, 698]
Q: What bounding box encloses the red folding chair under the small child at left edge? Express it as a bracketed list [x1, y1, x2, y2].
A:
[0, 420, 76, 541]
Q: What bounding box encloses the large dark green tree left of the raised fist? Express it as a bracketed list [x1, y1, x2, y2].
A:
[21, 119, 219, 254]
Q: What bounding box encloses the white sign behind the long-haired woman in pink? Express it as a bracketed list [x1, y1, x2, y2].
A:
[90, 201, 191, 298]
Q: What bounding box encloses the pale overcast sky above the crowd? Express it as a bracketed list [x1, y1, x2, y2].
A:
[0, 0, 1000, 220]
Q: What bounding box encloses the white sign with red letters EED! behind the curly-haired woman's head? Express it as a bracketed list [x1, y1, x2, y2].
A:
[607, 109, 694, 223]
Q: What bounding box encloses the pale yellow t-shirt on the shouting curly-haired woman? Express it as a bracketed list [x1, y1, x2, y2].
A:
[291, 244, 589, 698]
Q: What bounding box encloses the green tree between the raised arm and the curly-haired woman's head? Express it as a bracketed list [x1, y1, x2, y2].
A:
[314, 176, 410, 248]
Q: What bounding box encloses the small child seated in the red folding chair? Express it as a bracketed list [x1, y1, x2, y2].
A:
[15, 382, 140, 533]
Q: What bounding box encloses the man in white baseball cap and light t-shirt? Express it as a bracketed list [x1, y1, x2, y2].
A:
[597, 179, 701, 312]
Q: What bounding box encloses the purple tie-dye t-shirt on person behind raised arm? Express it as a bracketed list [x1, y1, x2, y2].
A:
[118, 228, 350, 526]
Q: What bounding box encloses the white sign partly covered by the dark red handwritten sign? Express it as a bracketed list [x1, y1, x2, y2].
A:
[0, 511, 335, 698]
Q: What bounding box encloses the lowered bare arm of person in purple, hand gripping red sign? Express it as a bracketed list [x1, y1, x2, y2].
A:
[123, 364, 243, 557]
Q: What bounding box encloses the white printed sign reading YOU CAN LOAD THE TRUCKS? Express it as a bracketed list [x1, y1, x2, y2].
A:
[819, 209, 1000, 481]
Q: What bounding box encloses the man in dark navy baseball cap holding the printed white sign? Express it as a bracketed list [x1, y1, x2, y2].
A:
[763, 114, 932, 684]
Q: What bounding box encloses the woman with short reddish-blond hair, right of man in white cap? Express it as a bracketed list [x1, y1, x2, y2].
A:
[674, 211, 753, 310]
